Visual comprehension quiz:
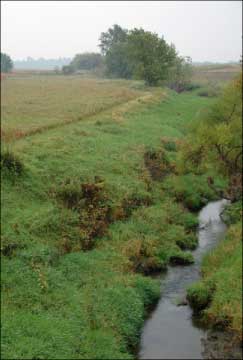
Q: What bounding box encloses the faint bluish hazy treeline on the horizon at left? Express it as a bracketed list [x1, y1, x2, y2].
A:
[14, 57, 72, 70]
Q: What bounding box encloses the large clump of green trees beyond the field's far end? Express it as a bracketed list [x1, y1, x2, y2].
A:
[99, 25, 189, 88]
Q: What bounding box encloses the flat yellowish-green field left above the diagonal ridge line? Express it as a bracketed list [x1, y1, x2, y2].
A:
[1, 72, 150, 141]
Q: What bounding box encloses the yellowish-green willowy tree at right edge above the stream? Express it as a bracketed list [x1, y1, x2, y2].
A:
[182, 75, 242, 199]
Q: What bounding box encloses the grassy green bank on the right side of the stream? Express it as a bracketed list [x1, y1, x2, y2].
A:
[187, 204, 242, 339]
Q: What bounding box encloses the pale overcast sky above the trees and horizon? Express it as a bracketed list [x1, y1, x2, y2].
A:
[1, 1, 242, 62]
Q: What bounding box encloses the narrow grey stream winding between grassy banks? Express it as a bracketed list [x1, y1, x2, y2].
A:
[138, 200, 227, 359]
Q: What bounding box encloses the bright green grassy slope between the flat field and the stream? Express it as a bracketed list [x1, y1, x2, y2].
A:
[2, 76, 230, 359]
